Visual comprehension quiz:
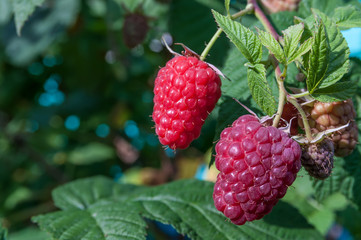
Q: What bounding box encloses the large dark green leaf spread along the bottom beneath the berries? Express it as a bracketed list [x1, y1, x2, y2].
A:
[33, 177, 321, 240]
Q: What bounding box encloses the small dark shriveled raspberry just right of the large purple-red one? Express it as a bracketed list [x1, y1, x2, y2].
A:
[301, 138, 334, 180]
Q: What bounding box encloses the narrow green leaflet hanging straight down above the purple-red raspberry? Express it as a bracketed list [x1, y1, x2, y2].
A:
[247, 64, 276, 116]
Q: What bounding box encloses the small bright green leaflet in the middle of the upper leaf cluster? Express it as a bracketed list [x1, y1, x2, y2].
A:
[283, 23, 304, 64]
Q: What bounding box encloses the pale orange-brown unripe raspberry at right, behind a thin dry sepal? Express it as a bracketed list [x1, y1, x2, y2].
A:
[299, 99, 358, 157]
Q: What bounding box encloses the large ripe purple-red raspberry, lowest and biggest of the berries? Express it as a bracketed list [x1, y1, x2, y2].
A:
[213, 115, 301, 225]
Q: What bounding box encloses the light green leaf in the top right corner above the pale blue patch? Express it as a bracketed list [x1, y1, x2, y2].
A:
[332, 5, 361, 29]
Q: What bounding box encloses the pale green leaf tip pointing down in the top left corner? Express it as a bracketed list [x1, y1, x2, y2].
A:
[12, 0, 45, 36]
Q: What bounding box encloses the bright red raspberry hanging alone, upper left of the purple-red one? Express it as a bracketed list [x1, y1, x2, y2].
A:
[153, 56, 221, 149]
